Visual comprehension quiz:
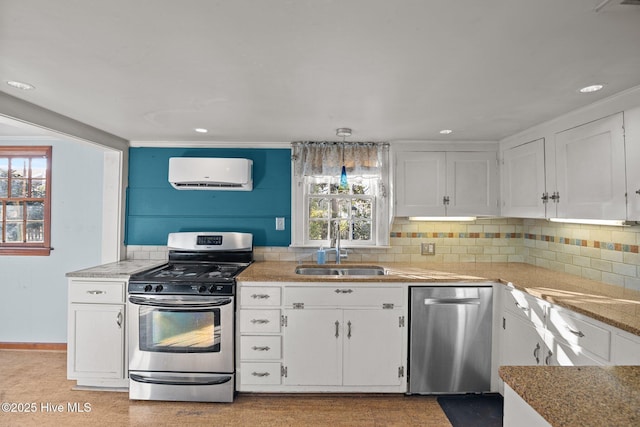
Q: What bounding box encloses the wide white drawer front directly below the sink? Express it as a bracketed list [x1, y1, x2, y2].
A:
[284, 283, 403, 307]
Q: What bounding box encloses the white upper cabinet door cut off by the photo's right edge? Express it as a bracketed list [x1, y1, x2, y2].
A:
[624, 107, 640, 221]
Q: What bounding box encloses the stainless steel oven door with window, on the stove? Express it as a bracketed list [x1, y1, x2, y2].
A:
[127, 295, 234, 373]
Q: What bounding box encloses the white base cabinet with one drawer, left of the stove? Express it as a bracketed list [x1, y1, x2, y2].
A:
[67, 278, 128, 388]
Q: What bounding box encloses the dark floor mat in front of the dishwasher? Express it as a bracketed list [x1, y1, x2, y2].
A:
[438, 393, 503, 427]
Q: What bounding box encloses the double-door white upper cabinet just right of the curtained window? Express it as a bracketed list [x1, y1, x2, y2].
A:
[395, 151, 498, 216]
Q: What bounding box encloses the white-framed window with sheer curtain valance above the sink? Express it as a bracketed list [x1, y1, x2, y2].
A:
[292, 142, 389, 247]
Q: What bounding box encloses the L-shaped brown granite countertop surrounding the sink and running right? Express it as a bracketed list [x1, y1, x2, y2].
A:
[238, 261, 640, 335]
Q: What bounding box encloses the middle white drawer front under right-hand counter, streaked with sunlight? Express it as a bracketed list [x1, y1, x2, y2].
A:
[547, 307, 611, 360]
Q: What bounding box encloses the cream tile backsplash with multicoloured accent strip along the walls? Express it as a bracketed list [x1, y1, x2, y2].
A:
[127, 218, 640, 290]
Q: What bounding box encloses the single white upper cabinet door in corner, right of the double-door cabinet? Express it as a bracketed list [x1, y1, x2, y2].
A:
[501, 138, 547, 218]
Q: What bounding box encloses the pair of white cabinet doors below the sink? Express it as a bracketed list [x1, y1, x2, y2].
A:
[284, 309, 404, 386]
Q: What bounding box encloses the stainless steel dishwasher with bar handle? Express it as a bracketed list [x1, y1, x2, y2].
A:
[409, 286, 493, 394]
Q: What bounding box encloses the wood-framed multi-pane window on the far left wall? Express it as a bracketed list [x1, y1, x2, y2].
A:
[0, 146, 52, 255]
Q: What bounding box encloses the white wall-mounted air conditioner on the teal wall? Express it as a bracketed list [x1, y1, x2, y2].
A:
[169, 157, 253, 191]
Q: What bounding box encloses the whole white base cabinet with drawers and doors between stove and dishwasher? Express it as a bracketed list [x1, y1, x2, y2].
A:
[237, 282, 407, 393]
